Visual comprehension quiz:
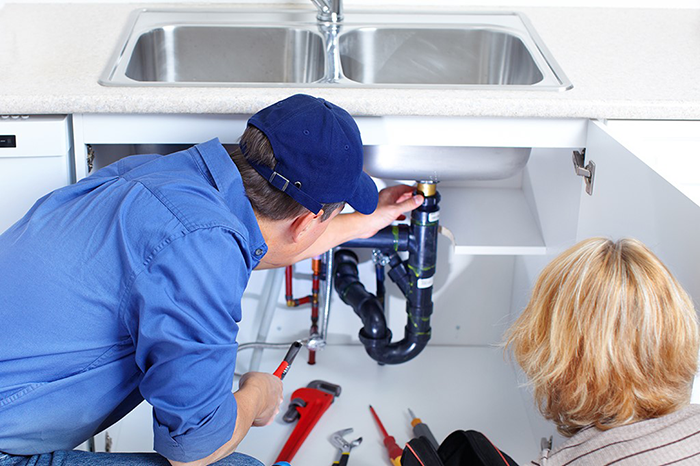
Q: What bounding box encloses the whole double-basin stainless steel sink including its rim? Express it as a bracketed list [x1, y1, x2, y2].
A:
[100, 9, 572, 91]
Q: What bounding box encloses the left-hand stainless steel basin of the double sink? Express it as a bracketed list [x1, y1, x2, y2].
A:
[125, 25, 325, 83]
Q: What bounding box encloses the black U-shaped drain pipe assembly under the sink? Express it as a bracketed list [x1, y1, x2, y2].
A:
[334, 183, 440, 364]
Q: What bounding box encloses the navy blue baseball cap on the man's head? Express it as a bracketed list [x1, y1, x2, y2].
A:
[241, 94, 379, 214]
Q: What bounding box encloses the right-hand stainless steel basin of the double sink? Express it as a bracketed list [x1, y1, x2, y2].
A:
[340, 28, 544, 86]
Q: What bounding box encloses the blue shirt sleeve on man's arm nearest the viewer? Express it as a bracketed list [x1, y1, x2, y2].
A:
[122, 228, 249, 462]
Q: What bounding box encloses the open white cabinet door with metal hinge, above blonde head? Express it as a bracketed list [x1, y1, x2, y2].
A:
[577, 122, 700, 402]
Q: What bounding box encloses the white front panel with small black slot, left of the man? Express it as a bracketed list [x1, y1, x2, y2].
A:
[0, 115, 73, 233]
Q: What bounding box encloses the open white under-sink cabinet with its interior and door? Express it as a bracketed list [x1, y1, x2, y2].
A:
[68, 115, 700, 465]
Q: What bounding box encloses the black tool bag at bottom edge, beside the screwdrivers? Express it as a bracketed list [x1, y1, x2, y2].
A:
[401, 430, 518, 466]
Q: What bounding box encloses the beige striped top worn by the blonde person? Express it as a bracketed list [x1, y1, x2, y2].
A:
[531, 405, 700, 466]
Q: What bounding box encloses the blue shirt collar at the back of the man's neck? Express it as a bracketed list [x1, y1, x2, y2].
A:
[194, 138, 267, 262]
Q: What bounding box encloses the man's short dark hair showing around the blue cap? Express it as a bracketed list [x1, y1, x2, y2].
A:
[230, 126, 345, 221]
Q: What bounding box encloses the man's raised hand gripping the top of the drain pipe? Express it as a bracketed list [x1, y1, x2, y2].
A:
[351, 184, 423, 239]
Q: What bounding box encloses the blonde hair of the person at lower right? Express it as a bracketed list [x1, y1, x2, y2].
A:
[505, 238, 698, 436]
